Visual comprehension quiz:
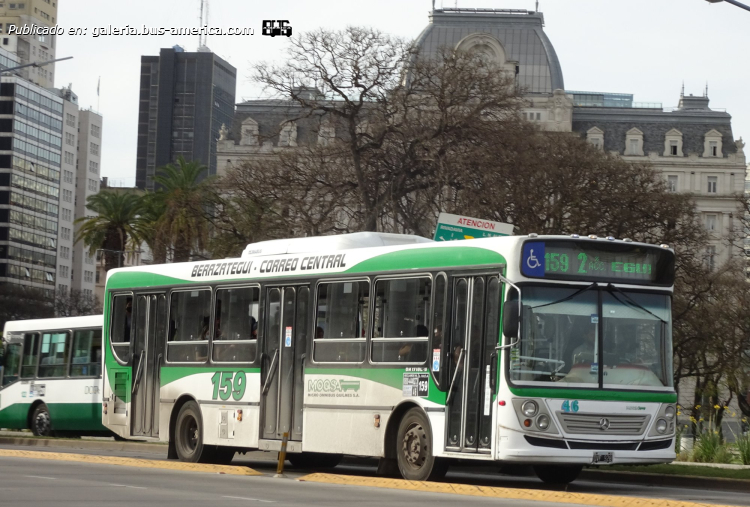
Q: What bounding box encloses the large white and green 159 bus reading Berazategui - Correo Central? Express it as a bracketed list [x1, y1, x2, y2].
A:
[103, 233, 676, 483]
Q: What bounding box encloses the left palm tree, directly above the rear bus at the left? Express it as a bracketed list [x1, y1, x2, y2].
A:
[75, 191, 143, 271]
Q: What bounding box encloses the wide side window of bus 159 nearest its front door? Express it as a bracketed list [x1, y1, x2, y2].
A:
[372, 278, 432, 364]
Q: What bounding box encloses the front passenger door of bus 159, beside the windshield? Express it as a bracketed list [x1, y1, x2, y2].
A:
[446, 276, 500, 453]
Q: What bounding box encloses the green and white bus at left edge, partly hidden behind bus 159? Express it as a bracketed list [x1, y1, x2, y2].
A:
[0, 315, 110, 436]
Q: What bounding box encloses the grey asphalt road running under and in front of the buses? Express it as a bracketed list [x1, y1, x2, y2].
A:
[0, 443, 750, 507]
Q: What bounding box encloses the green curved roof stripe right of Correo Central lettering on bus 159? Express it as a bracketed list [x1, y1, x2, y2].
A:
[346, 247, 505, 273]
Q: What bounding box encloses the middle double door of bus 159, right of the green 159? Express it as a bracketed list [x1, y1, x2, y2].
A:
[261, 287, 310, 441]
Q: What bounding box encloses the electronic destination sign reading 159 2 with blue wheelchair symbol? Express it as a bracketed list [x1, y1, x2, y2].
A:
[521, 239, 674, 286]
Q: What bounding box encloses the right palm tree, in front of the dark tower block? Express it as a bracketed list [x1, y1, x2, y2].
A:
[151, 156, 213, 262]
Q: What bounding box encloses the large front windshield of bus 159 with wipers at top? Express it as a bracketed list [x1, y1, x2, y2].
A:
[510, 286, 672, 389]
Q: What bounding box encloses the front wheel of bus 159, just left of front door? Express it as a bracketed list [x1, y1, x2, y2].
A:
[396, 408, 448, 481]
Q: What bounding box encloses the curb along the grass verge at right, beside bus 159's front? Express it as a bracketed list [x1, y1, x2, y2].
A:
[588, 469, 750, 493]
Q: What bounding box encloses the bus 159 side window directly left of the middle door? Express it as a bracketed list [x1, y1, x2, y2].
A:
[213, 287, 260, 363]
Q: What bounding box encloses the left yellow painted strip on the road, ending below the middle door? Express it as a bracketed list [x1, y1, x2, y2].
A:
[0, 449, 263, 475]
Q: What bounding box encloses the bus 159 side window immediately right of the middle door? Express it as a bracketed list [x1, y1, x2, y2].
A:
[313, 281, 370, 363]
